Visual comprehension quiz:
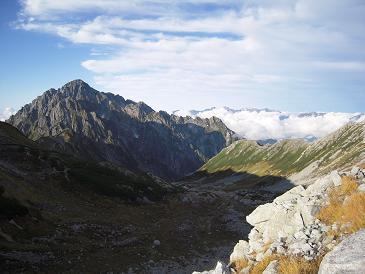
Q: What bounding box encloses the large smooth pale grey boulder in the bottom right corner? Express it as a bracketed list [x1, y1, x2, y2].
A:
[318, 229, 365, 274]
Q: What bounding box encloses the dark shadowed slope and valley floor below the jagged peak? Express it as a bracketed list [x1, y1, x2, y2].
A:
[0, 122, 252, 273]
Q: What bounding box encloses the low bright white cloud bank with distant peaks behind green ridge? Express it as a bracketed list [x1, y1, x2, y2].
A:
[173, 107, 365, 142]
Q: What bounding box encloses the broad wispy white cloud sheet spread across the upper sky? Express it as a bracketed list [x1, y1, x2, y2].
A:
[16, 0, 365, 109]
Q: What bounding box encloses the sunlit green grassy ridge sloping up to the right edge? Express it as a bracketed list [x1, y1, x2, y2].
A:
[200, 121, 365, 184]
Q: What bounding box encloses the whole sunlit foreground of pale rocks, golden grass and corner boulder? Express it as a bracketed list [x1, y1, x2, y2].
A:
[193, 167, 365, 274]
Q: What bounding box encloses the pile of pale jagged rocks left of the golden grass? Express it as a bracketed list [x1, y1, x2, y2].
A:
[195, 167, 365, 273]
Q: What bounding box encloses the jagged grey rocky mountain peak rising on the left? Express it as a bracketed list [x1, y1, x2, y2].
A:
[7, 80, 235, 180]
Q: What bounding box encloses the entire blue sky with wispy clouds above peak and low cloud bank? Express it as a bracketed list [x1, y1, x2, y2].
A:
[0, 0, 365, 119]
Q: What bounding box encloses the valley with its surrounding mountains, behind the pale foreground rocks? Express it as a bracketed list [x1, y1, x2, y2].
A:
[0, 80, 365, 274]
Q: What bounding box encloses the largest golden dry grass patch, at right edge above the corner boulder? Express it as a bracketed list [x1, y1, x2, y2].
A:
[317, 177, 365, 236]
